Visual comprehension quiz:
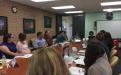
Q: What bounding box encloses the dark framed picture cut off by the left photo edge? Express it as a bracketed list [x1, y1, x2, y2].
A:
[0, 16, 8, 35]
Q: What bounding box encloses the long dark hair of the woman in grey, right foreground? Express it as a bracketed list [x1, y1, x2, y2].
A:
[84, 40, 104, 74]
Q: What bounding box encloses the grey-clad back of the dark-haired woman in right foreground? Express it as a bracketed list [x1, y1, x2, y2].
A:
[88, 57, 112, 75]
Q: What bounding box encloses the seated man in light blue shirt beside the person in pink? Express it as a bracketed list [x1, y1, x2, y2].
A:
[34, 32, 47, 48]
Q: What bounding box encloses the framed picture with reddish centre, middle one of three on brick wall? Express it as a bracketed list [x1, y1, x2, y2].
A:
[23, 18, 35, 34]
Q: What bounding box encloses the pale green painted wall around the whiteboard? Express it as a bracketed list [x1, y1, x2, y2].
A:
[85, 12, 121, 37]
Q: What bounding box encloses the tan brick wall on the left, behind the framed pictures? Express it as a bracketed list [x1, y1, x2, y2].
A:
[0, 0, 56, 40]
